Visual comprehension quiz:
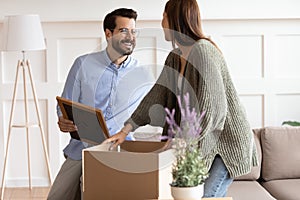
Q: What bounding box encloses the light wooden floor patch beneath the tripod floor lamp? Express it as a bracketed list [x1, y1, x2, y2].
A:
[4, 187, 50, 200]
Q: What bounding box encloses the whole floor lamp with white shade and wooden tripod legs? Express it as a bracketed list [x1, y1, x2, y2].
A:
[1, 15, 52, 199]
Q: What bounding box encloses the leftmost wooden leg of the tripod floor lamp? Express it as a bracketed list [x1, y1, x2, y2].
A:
[1, 60, 21, 200]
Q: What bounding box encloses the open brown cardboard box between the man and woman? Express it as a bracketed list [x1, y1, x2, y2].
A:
[83, 141, 174, 200]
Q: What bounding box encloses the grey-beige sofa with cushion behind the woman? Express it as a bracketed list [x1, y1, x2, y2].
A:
[227, 127, 300, 200]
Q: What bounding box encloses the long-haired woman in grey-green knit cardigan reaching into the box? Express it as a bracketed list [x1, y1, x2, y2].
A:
[107, 0, 257, 197]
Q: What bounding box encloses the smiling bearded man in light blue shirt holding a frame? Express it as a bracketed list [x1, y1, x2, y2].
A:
[48, 8, 154, 200]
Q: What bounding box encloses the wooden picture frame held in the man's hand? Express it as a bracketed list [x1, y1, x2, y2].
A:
[56, 96, 110, 144]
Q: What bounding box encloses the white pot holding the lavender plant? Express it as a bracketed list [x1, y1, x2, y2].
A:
[171, 184, 204, 200]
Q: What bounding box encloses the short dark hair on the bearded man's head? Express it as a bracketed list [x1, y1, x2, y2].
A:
[103, 8, 137, 31]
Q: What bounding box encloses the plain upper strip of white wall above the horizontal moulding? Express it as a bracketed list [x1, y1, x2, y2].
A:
[0, 0, 300, 21]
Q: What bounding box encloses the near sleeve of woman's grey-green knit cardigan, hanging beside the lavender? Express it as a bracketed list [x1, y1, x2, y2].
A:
[185, 40, 227, 141]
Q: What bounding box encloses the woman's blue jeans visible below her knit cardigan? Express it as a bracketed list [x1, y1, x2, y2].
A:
[203, 155, 233, 197]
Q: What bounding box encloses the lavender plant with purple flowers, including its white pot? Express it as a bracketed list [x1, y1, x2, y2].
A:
[165, 93, 208, 199]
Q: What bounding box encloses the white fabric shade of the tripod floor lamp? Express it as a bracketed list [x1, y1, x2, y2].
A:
[2, 15, 46, 51]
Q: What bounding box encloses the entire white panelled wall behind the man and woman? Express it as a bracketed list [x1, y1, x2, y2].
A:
[0, 0, 300, 186]
